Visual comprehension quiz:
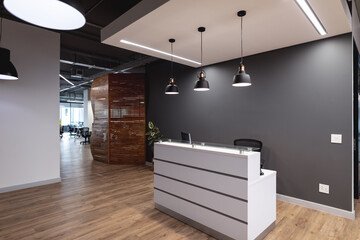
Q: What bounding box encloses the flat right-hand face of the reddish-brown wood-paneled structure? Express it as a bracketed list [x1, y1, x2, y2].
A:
[109, 74, 145, 164]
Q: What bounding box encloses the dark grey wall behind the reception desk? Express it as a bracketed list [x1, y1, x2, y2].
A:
[147, 34, 352, 211]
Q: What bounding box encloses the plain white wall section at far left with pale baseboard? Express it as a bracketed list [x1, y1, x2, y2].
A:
[0, 19, 60, 192]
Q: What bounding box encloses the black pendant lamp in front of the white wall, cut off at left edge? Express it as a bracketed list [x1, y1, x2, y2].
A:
[0, 9, 19, 80]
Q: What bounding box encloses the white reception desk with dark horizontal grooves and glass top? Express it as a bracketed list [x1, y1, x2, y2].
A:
[154, 141, 276, 240]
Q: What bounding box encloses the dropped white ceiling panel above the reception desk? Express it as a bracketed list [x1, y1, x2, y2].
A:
[102, 0, 350, 67]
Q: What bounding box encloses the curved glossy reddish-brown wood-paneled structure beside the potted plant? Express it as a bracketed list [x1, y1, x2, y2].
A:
[91, 74, 146, 164]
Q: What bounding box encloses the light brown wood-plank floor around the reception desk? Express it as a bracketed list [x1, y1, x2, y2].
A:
[0, 136, 360, 240]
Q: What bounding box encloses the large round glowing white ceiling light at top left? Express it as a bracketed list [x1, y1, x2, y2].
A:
[4, 0, 86, 30]
